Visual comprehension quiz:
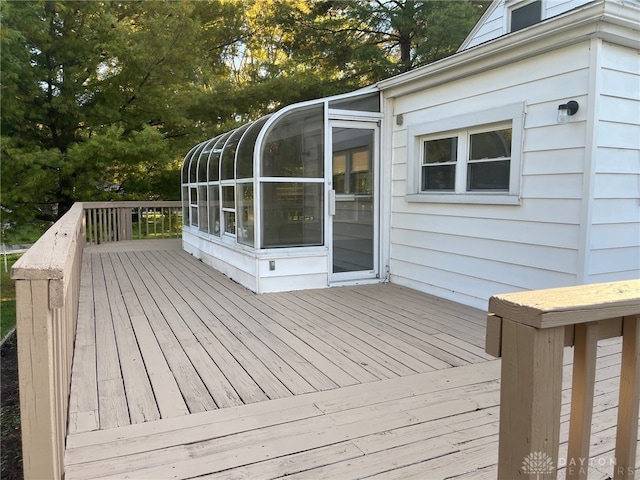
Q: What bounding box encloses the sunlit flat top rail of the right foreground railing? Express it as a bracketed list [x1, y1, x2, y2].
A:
[489, 279, 640, 328]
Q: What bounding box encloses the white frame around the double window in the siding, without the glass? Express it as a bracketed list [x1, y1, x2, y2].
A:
[405, 103, 526, 205]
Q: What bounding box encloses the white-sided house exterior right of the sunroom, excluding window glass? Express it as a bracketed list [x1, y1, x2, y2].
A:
[379, 0, 640, 307]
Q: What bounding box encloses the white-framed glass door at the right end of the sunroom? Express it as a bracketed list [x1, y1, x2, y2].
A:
[327, 120, 379, 283]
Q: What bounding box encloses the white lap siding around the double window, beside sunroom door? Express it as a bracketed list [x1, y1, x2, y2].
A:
[390, 44, 589, 308]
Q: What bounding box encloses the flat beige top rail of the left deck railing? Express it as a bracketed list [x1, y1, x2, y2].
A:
[11, 203, 84, 280]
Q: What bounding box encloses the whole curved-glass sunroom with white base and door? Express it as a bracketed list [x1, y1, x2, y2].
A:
[182, 88, 382, 293]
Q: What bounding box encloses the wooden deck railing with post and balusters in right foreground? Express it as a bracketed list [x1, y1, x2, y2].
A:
[486, 280, 640, 480]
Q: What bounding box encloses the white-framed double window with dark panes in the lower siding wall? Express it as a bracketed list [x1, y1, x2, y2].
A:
[407, 104, 524, 204]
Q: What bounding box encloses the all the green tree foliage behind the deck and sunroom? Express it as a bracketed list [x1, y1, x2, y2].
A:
[0, 0, 488, 229]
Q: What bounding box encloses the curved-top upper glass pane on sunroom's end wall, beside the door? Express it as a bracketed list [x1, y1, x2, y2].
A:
[261, 105, 324, 178]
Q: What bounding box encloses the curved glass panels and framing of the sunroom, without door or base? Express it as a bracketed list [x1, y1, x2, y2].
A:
[181, 88, 381, 248]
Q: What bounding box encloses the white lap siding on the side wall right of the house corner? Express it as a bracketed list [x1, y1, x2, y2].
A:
[587, 43, 640, 283]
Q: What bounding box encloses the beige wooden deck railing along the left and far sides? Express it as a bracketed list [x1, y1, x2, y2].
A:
[11, 202, 181, 479]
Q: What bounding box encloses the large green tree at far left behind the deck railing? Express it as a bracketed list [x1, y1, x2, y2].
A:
[1, 1, 237, 224]
